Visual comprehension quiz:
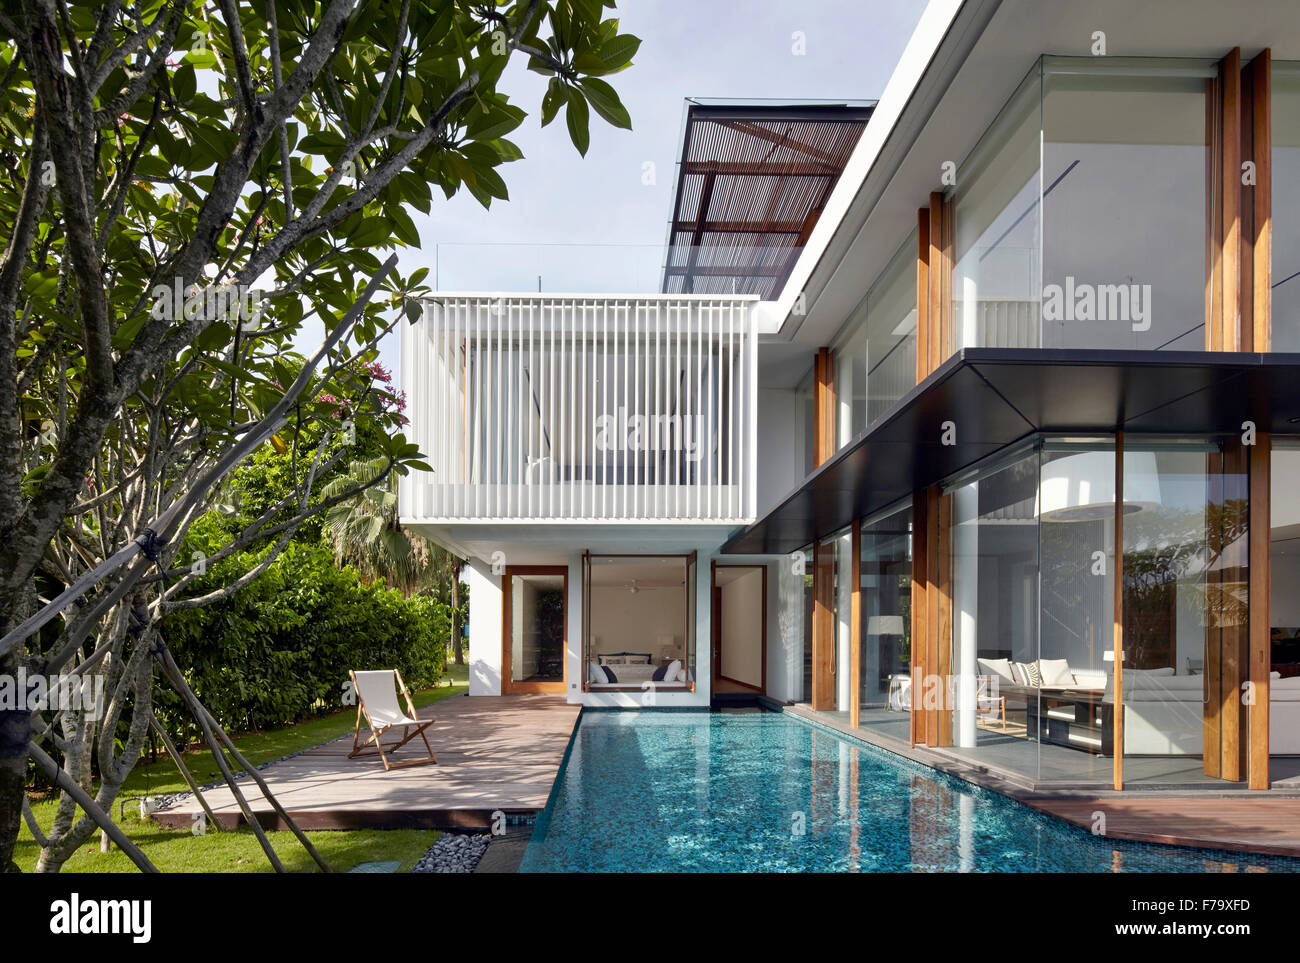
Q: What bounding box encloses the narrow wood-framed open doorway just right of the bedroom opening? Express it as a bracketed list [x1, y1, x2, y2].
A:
[711, 563, 767, 694]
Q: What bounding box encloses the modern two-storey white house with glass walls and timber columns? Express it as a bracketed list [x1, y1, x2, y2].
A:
[400, 0, 1300, 790]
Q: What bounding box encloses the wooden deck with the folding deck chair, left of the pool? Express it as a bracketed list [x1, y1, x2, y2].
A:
[155, 695, 580, 829]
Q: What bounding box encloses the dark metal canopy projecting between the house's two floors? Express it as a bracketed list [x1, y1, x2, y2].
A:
[722, 348, 1300, 555]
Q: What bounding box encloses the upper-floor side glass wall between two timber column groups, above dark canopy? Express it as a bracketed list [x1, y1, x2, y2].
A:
[833, 231, 917, 446]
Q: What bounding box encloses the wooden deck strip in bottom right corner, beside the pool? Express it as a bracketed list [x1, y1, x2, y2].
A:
[1022, 793, 1300, 856]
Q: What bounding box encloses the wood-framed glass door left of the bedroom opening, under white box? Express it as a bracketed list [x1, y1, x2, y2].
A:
[502, 565, 568, 693]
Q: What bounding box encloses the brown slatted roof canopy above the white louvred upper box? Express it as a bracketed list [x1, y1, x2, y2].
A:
[663, 103, 874, 299]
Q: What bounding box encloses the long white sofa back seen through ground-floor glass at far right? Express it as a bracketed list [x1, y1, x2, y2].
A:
[1102, 669, 1300, 755]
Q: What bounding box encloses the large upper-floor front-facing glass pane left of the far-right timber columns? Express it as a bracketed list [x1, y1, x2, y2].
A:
[1043, 57, 1217, 350]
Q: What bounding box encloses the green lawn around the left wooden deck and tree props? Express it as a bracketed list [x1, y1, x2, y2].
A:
[14, 665, 469, 873]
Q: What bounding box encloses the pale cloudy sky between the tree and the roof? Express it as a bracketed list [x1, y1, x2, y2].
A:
[300, 0, 926, 384]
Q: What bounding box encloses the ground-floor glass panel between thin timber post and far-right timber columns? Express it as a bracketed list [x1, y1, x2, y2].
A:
[1123, 438, 1249, 789]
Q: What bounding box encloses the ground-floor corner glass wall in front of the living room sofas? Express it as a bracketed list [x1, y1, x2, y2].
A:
[940, 438, 1263, 788]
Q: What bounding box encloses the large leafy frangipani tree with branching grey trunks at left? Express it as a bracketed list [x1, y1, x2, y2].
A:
[0, 0, 638, 869]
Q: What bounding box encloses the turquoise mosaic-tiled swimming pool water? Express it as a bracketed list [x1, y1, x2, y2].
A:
[520, 710, 1300, 872]
